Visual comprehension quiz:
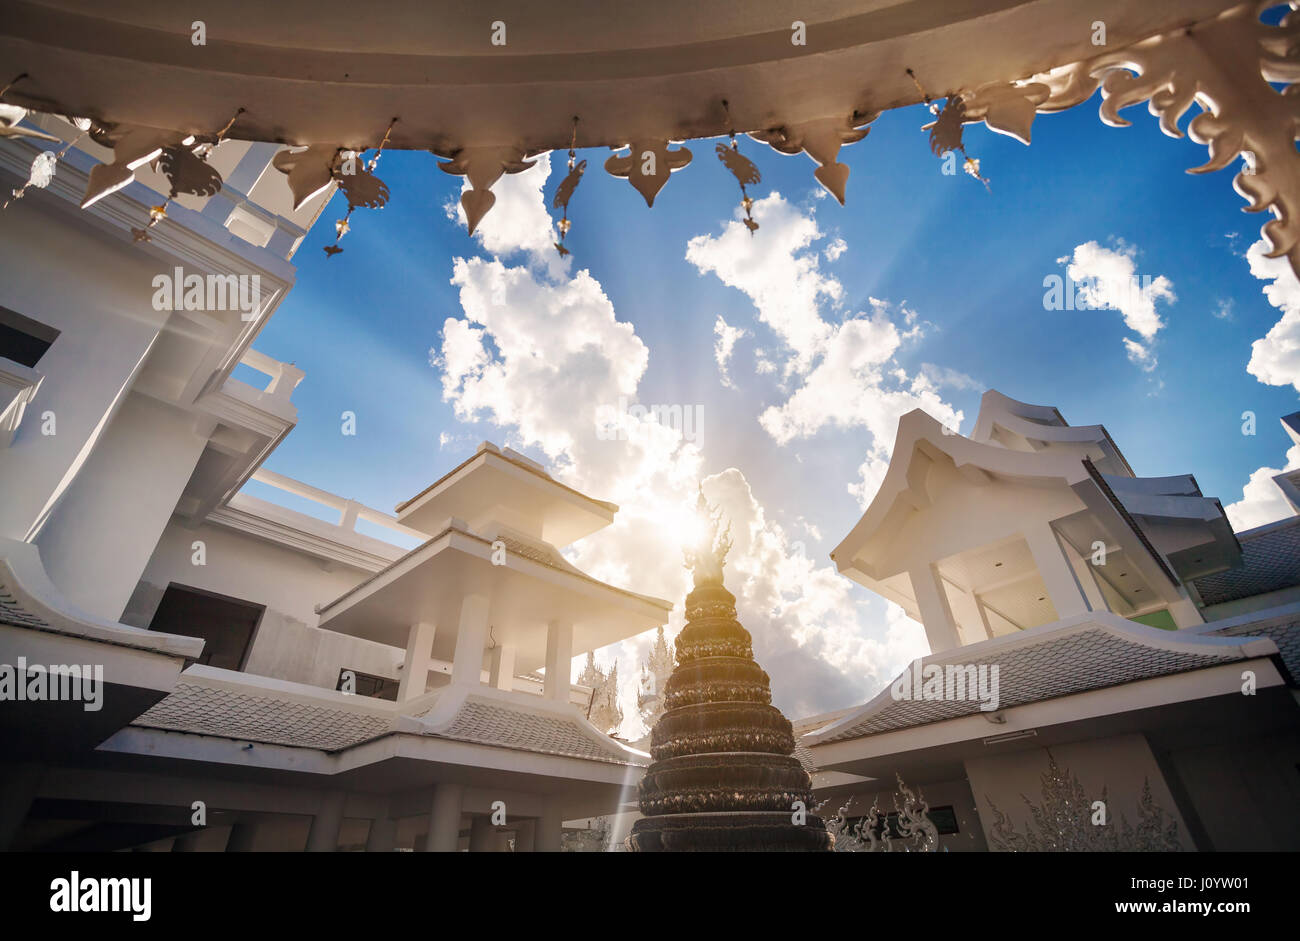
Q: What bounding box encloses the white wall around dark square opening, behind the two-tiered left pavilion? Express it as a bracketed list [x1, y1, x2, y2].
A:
[122, 519, 404, 689]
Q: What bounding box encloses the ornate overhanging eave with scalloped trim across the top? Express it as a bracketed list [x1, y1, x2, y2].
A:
[0, 0, 1300, 270]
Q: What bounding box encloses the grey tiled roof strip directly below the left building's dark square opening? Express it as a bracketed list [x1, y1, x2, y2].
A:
[133, 680, 393, 751]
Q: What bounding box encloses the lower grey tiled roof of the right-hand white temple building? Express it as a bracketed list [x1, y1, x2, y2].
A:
[819, 626, 1249, 743]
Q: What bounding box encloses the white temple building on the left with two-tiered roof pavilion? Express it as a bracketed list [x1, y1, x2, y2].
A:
[0, 117, 671, 850]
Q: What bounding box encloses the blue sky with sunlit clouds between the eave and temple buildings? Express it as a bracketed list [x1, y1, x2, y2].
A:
[239, 96, 1300, 715]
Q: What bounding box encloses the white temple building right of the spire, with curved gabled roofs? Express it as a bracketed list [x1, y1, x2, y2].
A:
[796, 391, 1300, 850]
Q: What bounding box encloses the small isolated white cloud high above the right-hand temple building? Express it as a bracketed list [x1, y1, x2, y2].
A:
[1058, 242, 1178, 372]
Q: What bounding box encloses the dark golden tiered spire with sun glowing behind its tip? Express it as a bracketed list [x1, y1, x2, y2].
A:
[628, 494, 832, 853]
